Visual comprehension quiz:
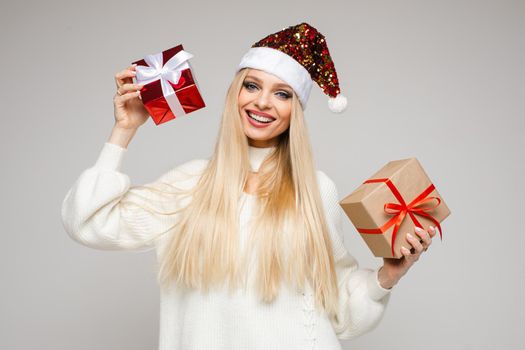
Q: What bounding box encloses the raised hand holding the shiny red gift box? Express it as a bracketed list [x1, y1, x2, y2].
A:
[113, 65, 149, 130]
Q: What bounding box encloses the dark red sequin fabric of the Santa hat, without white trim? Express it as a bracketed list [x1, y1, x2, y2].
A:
[252, 22, 340, 97]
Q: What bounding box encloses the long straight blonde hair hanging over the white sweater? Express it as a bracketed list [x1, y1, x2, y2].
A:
[127, 69, 339, 316]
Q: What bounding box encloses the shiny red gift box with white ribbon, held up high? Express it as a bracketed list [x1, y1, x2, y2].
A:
[133, 45, 206, 125]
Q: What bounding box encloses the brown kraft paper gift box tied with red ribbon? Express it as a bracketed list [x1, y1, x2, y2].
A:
[339, 158, 450, 259]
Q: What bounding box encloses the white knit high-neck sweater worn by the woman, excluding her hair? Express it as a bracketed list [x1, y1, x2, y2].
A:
[62, 142, 391, 350]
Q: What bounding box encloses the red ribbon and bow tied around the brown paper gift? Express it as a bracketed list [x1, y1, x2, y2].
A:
[357, 179, 443, 257]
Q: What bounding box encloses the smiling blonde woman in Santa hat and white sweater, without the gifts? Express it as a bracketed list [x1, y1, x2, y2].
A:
[62, 23, 435, 350]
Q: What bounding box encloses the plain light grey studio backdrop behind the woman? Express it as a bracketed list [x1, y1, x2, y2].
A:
[0, 0, 525, 350]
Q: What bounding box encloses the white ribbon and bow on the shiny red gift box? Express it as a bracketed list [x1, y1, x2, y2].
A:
[135, 50, 193, 116]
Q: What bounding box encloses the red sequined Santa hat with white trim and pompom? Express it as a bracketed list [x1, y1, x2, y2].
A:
[237, 22, 347, 113]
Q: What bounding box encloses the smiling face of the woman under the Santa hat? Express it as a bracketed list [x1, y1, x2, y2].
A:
[238, 69, 293, 147]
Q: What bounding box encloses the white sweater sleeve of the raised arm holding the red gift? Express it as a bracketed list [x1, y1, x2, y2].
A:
[61, 142, 206, 251]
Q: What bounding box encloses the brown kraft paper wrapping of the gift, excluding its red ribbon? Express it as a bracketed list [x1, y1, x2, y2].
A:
[339, 158, 450, 259]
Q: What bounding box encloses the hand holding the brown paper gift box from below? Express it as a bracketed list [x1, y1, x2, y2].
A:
[379, 226, 436, 288]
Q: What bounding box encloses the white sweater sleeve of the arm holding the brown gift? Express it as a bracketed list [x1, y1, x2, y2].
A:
[319, 171, 392, 339]
